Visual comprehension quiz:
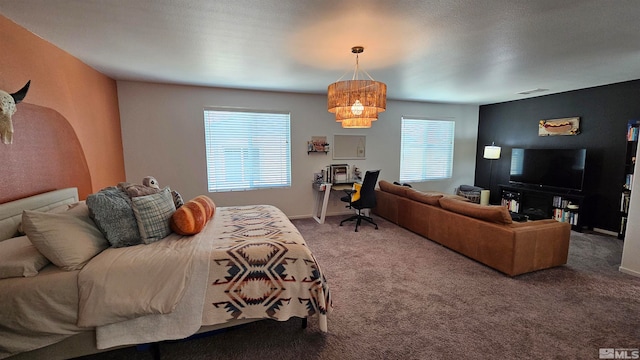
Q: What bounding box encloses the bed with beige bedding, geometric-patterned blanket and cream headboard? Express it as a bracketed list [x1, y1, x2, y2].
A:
[0, 188, 332, 359]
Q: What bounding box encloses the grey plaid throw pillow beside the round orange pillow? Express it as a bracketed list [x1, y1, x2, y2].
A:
[131, 187, 176, 244]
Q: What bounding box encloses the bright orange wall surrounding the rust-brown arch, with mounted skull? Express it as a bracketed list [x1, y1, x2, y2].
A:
[0, 15, 125, 199]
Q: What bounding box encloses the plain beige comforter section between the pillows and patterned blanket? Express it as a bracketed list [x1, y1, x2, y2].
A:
[78, 227, 213, 349]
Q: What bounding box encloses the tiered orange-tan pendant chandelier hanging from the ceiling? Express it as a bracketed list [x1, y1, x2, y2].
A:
[327, 46, 387, 129]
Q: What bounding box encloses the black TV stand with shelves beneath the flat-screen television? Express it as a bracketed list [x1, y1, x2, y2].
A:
[499, 184, 588, 231]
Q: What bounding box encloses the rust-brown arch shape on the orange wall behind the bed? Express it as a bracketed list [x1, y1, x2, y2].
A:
[0, 102, 91, 203]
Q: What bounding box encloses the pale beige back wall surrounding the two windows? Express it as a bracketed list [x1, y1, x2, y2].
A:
[118, 81, 479, 218]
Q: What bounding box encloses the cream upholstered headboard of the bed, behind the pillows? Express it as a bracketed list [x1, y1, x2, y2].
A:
[0, 188, 78, 241]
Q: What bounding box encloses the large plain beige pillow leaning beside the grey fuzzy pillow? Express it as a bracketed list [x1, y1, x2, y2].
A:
[22, 204, 109, 270]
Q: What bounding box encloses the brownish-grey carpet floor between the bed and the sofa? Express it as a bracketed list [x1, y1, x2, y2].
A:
[76, 217, 640, 360]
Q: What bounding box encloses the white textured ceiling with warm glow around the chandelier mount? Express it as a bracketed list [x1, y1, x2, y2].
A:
[0, 0, 640, 104]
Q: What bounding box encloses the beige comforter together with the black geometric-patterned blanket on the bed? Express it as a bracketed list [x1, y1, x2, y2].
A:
[78, 205, 331, 349]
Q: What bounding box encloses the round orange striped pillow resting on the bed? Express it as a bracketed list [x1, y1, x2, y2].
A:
[169, 195, 216, 235]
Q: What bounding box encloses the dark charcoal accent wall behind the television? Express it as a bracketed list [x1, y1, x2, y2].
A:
[475, 80, 640, 232]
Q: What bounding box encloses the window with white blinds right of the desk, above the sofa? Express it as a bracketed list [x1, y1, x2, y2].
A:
[400, 117, 455, 182]
